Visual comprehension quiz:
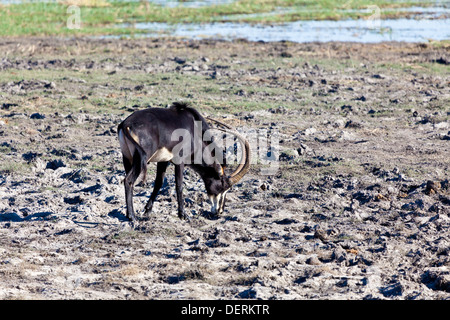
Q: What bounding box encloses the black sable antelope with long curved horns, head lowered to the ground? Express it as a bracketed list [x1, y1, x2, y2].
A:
[117, 102, 251, 221]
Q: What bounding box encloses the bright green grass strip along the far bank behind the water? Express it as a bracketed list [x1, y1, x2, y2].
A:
[0, 0, 442, 36]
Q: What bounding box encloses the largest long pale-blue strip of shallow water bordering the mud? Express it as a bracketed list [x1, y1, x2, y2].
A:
[128, 19, 450, 43]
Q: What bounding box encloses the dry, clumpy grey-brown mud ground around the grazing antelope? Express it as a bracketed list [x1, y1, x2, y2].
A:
[0, 38, 450, 299]
